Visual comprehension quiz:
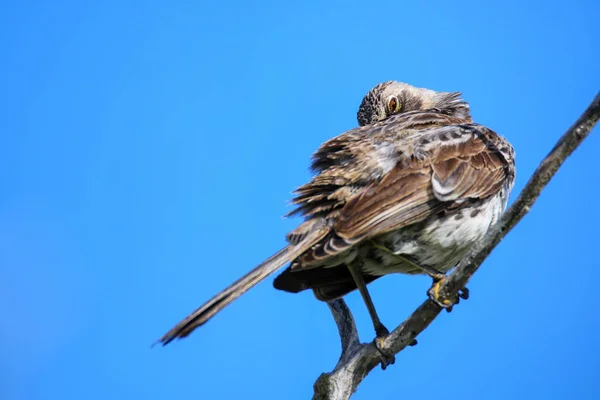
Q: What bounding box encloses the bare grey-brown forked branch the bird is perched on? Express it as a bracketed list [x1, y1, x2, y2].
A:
[313, 92, 600, 400]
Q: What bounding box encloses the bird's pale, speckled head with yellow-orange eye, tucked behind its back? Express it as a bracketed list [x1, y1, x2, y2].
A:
[357, 81, 471, 126]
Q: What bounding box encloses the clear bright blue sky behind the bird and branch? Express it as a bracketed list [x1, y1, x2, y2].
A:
[0, 0, 600, 400]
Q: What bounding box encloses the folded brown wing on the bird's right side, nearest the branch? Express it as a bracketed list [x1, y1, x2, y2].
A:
[296, 124, 514, 268]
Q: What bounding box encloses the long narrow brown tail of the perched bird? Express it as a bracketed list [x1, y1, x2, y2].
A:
[156, 225, 327, 346]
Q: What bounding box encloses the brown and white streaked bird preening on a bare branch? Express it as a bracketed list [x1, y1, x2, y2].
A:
[158, 81, 516, 345]
